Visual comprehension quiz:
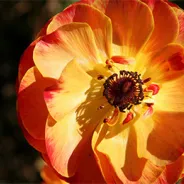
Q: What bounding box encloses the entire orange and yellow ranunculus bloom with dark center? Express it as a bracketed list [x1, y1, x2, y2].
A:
[17, 0, 184, 184]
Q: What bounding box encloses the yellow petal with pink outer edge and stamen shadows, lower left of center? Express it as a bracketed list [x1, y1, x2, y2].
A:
[46, 93, 107, 177]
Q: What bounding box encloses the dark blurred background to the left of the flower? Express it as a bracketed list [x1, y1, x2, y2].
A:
[0, 0, 184, 183]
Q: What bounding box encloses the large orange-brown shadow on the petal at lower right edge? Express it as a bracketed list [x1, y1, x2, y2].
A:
[147, 111, 184, 162]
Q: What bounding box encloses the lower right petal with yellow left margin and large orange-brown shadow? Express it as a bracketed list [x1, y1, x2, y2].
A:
[135, 110, 184, 166]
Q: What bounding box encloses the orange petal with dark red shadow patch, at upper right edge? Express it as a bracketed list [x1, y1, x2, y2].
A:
[143, 44, 184, 83]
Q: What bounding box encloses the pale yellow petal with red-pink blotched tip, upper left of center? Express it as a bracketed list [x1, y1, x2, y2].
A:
[33, 23, 100, 79]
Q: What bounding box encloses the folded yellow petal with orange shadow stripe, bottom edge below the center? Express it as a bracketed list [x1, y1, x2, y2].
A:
[92, 121, 164, 184]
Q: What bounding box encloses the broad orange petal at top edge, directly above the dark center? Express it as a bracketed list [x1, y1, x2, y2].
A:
[93, 0, 154, 57]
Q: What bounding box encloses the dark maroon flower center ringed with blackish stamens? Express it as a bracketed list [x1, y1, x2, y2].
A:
[103, 70, 144, 112]
